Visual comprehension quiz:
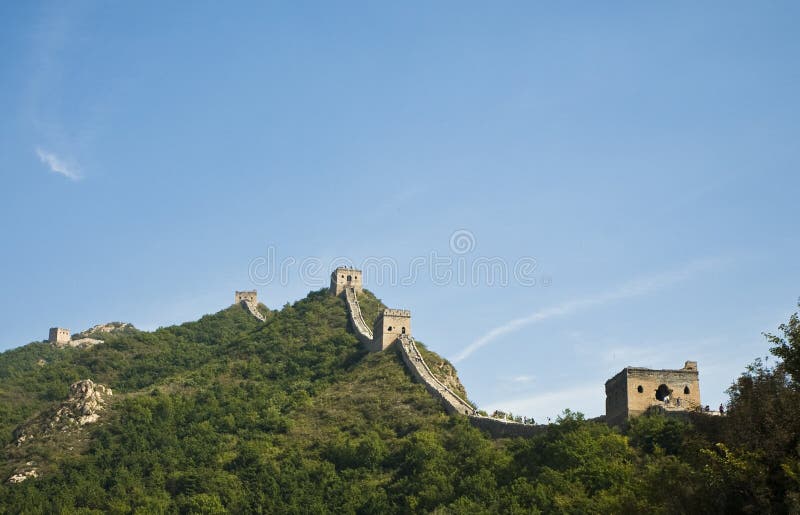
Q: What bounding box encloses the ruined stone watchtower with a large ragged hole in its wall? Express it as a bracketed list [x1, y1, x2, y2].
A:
[606, 361, 701, 425]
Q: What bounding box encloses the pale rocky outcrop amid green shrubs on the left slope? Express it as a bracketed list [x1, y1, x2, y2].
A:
[15, 379, 112, 446]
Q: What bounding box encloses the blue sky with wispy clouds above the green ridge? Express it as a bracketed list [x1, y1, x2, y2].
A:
[0, 1, 800, 420]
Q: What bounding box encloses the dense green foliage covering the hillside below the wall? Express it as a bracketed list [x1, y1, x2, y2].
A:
[0, 291, 800, 513]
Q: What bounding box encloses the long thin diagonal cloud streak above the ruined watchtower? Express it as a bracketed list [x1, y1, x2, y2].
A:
[453, 259, 719, 363]
